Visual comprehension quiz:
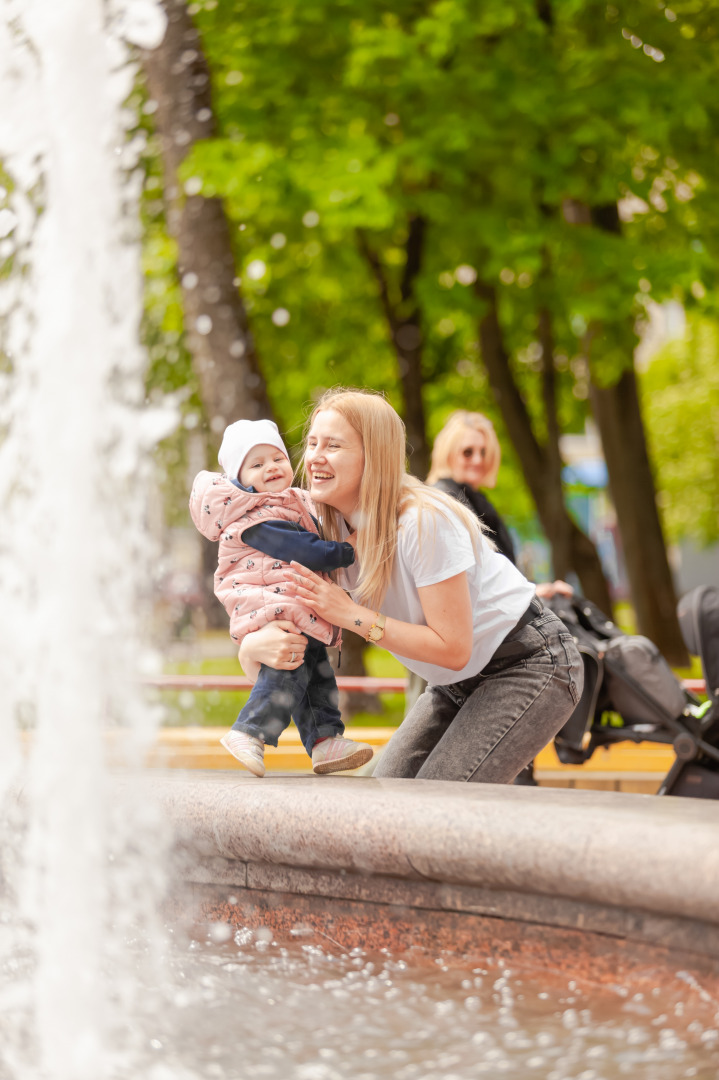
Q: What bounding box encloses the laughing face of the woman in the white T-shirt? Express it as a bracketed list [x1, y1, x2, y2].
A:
[304, 408, 365, 519]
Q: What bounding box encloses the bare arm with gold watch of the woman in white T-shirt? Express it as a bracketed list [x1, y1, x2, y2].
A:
[286, 563, 472, 671]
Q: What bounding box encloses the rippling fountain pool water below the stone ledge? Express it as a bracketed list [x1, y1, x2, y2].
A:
[117, 924, 719, 1080]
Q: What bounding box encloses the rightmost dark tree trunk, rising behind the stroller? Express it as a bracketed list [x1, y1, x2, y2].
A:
[587, 203, 689, 665]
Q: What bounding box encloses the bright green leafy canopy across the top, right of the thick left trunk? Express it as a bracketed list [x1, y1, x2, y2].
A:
[159, 0, 719, 544]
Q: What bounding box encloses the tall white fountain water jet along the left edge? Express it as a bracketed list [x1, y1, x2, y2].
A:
[0, 0, 166, 1080]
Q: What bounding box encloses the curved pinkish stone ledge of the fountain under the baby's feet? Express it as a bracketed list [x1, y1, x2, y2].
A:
[152, 773, 719, 941]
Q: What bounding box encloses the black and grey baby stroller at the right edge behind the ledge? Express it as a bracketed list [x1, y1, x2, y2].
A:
[547, 585, 719, 799]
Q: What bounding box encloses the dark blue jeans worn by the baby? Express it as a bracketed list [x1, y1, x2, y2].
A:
[232, 637, 344, 755]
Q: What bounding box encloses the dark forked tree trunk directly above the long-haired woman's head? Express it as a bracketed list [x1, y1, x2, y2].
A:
[357, 216, 430, 478]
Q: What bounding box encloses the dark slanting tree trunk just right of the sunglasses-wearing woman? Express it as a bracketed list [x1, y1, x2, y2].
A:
[475, 282, 612, 615]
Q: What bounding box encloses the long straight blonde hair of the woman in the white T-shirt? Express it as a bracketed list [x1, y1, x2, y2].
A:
[304, 387, 493, 608]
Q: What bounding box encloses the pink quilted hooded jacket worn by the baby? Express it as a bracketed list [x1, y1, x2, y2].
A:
[190, 472, 341, 645]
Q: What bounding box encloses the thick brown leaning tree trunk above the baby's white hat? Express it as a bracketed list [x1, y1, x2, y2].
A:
[144, 0, 272, 445]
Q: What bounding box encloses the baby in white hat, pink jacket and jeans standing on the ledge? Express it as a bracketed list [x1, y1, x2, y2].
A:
[190, 420, 372, 777]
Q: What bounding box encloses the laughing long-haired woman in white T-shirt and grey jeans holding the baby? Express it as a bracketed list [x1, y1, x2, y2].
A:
[240, 391, 582, 783]
